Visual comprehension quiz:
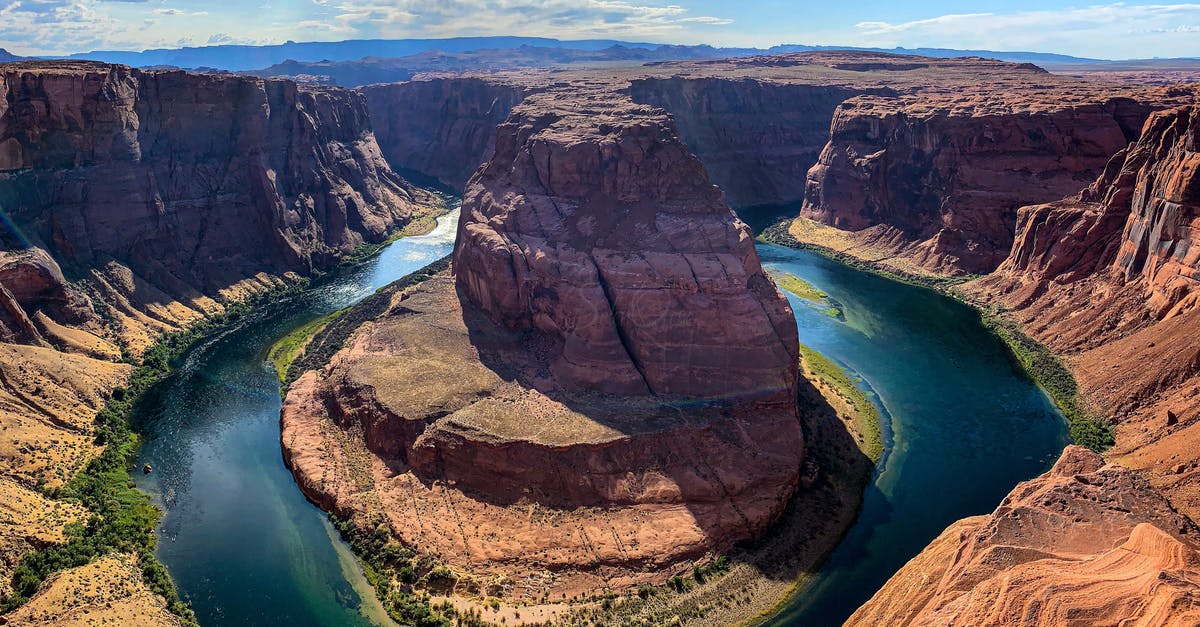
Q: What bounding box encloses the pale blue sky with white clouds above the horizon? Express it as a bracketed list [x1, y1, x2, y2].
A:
[0, 0, 1200, 59]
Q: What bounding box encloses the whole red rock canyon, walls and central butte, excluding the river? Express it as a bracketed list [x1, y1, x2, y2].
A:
[0, 52, 1200, 625]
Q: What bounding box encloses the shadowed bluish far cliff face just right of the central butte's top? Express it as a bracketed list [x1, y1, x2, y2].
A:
[629, 77, 873, 208]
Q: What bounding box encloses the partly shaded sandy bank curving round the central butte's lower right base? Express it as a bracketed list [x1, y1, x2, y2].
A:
[558, 360, 882, 627]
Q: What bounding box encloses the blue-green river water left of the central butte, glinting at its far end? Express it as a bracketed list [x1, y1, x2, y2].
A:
[137, 211, 457, 626]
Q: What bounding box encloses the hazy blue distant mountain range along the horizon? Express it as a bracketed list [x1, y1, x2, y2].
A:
[0, 37, 1200, 76]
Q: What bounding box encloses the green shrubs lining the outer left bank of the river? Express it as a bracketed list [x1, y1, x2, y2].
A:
[0, 282, 306, 625]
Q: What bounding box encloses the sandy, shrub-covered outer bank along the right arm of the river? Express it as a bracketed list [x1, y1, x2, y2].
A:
[758, 219, 1115, 453]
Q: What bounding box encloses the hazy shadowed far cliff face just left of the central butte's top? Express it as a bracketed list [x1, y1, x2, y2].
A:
[359, 78, 532, 190]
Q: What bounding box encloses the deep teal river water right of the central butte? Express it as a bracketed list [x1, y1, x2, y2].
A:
[758, 244, 1068, 626]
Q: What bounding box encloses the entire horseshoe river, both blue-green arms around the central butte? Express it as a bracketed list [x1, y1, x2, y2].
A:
[137, 213, 1066, 626]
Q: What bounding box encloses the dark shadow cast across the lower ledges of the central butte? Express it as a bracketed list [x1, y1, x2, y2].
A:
[441, 278, 874, 581]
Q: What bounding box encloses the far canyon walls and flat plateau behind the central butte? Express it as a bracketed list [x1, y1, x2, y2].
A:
[364, 52, 1196, 275]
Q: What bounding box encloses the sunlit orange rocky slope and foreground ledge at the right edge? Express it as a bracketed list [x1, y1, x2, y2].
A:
[851, 102, 1200, 625]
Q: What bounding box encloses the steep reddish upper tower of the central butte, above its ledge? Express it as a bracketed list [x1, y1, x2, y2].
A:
[454, 87, 798, 396]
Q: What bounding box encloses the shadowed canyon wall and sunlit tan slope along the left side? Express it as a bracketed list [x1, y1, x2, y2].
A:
[0, 61, 426, 622]
